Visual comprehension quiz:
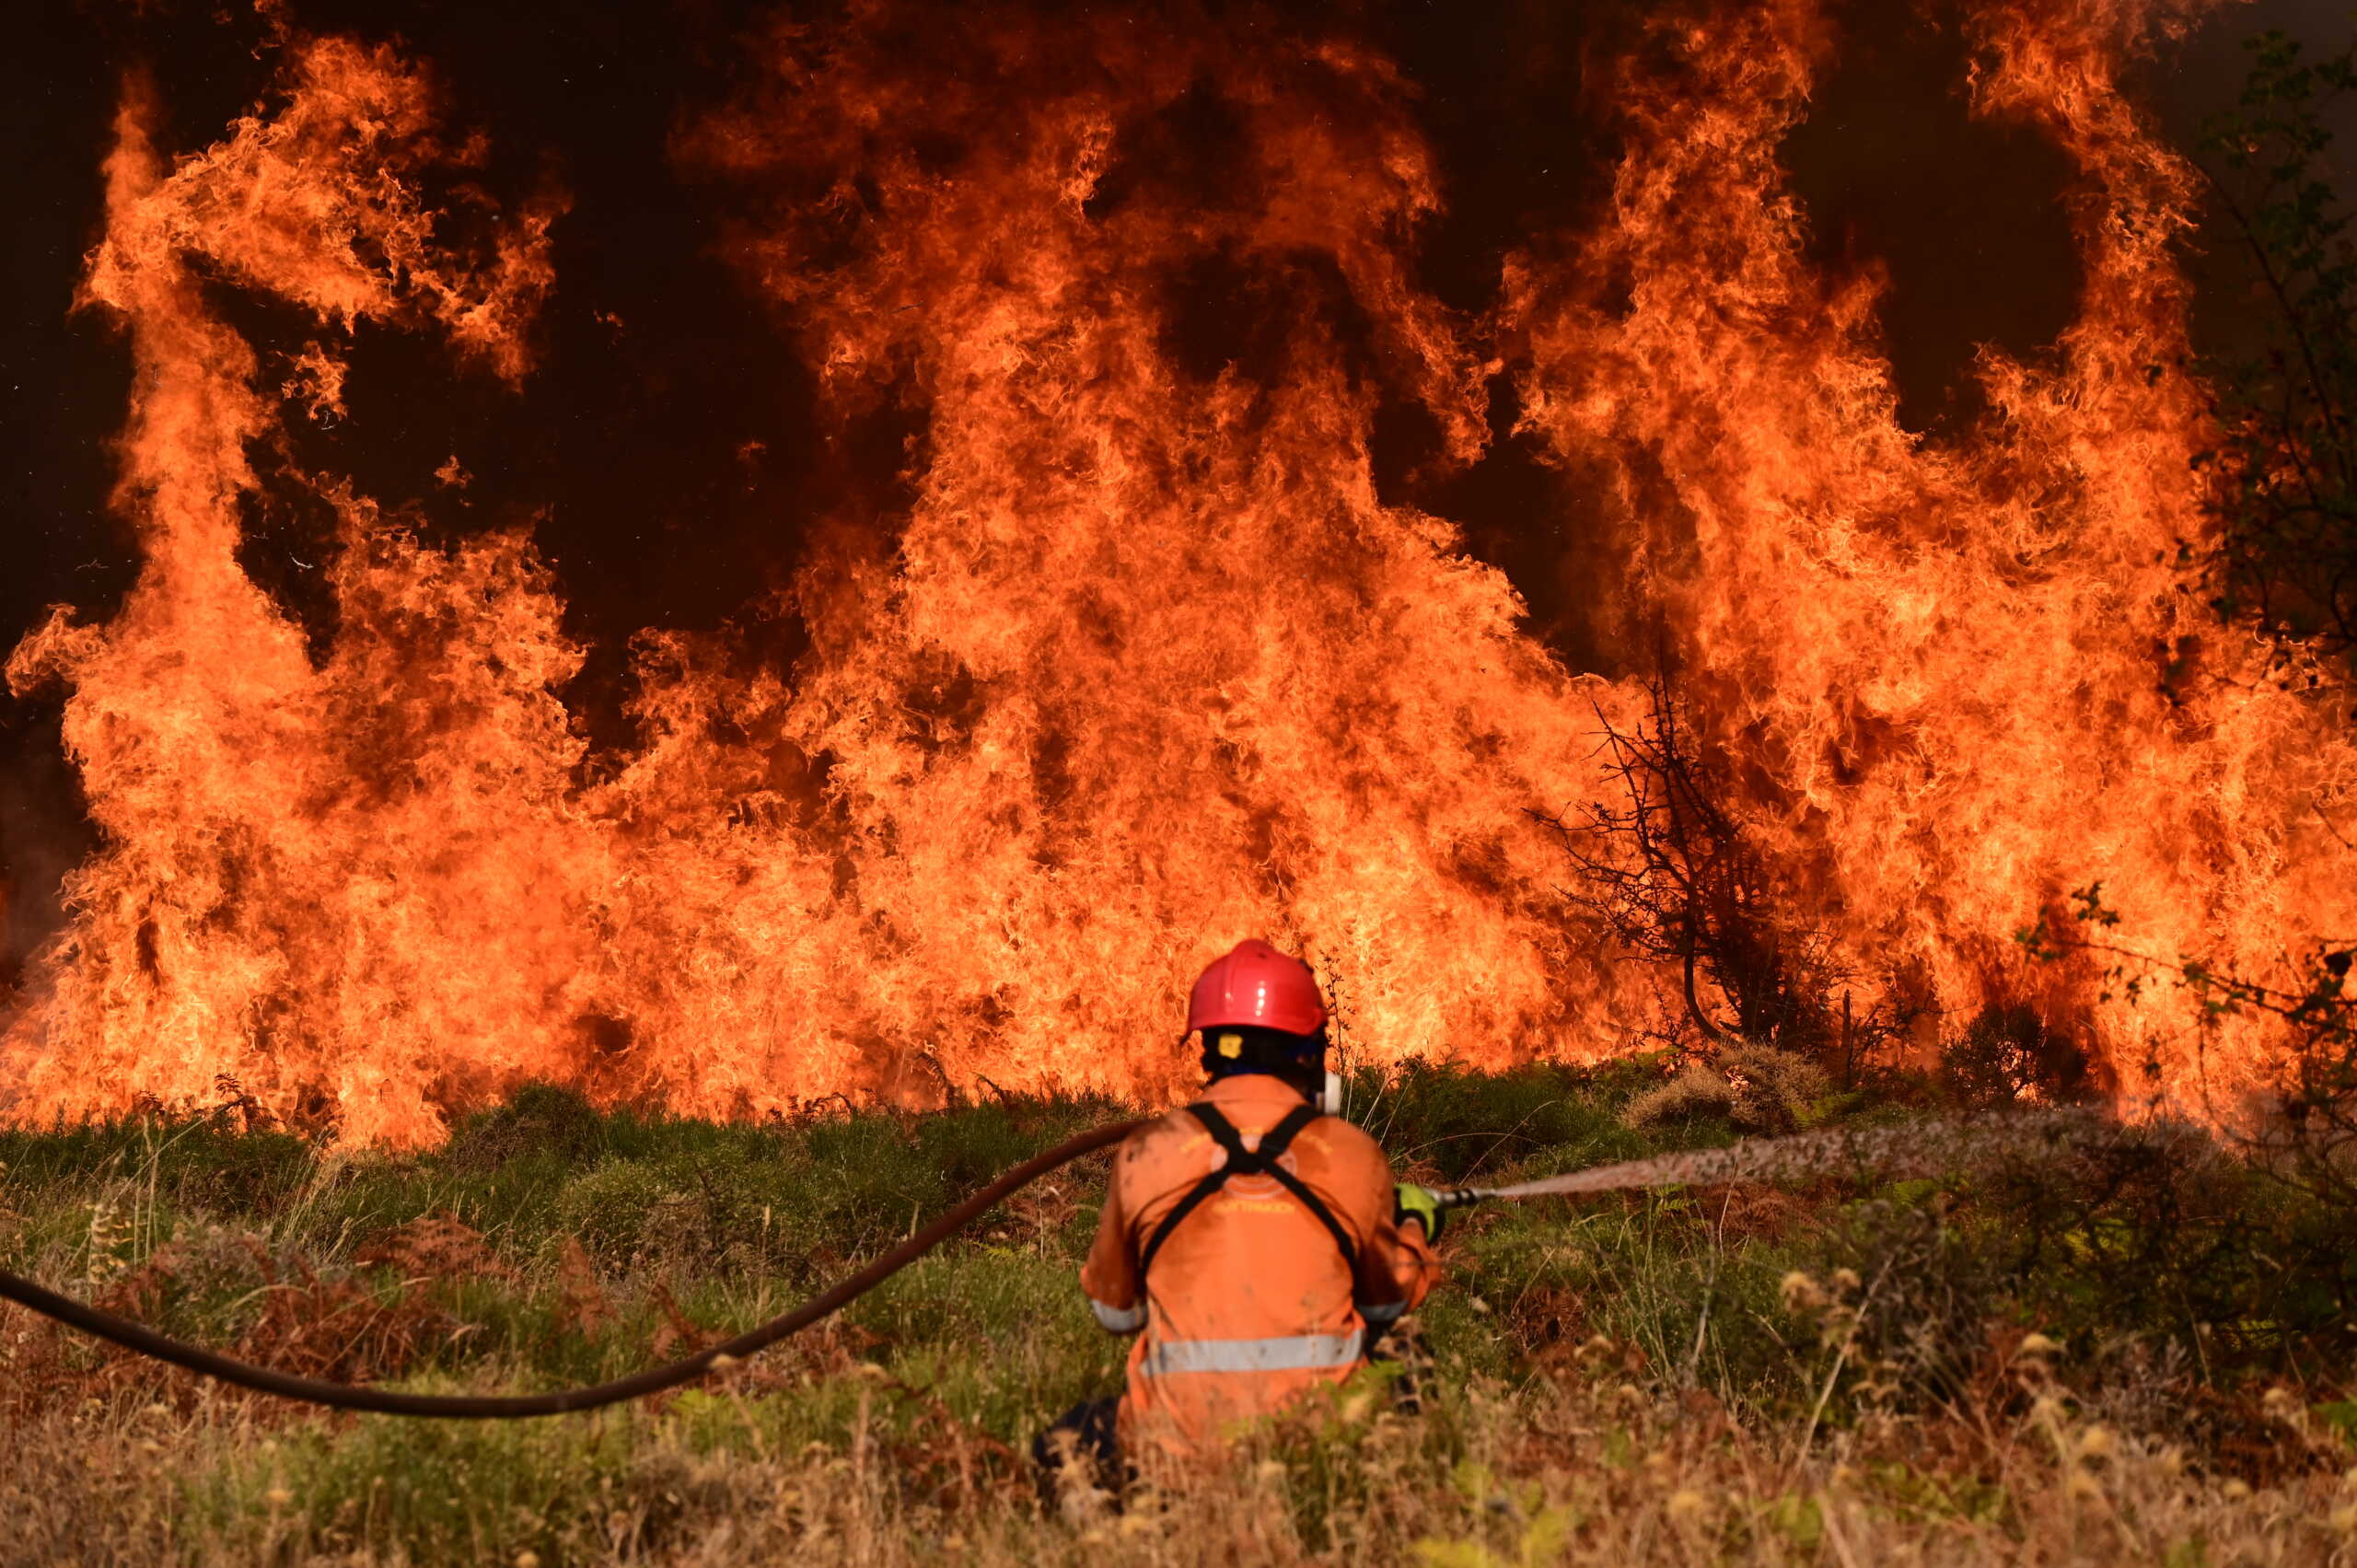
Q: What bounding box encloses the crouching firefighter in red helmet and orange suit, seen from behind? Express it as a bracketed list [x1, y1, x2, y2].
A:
[1037, 941, 1440, 1476]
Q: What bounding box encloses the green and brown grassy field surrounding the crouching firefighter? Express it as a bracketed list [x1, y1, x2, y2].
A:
[0, 1068, 2357, 1568]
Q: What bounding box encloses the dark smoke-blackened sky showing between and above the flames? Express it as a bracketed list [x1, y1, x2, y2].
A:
[0, 0, 2348, 966]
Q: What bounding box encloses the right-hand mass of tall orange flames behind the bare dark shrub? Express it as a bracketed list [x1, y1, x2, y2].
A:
[1508, 0, 2357, 1110]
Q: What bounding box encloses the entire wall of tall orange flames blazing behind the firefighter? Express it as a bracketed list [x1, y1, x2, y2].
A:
[0, 0, 2357, 1144]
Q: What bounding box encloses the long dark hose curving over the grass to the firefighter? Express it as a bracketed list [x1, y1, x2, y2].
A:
[0, 1122, 1144, 1422]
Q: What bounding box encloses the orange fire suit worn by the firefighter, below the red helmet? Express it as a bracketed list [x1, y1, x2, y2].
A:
[1079, 1073, 1438, 1458]
